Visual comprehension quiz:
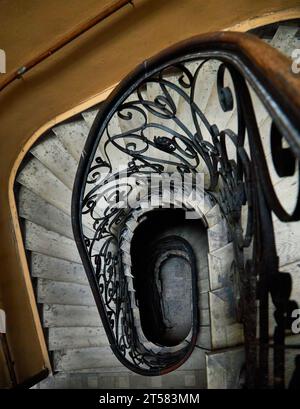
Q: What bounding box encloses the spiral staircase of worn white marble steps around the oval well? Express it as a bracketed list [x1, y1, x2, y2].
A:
[15, 22, 300, 389]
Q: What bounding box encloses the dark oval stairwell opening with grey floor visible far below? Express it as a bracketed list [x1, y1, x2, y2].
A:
[131, 209, 206, 346]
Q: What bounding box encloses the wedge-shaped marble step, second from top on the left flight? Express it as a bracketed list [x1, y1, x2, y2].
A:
[52, 117, 90, 162]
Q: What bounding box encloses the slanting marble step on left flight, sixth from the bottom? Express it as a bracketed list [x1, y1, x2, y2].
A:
[25, 220, 81, 264]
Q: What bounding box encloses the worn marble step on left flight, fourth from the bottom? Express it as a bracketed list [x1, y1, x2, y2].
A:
[37, 279, 95, 306]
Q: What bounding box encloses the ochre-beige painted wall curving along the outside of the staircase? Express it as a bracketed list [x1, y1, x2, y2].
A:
[0, 0, 300, 381]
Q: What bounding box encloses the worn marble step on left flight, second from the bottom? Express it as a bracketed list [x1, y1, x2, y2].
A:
[48, 326, 109, 351]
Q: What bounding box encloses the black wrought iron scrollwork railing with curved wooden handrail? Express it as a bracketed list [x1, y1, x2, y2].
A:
[72, 32, 300, 382]
